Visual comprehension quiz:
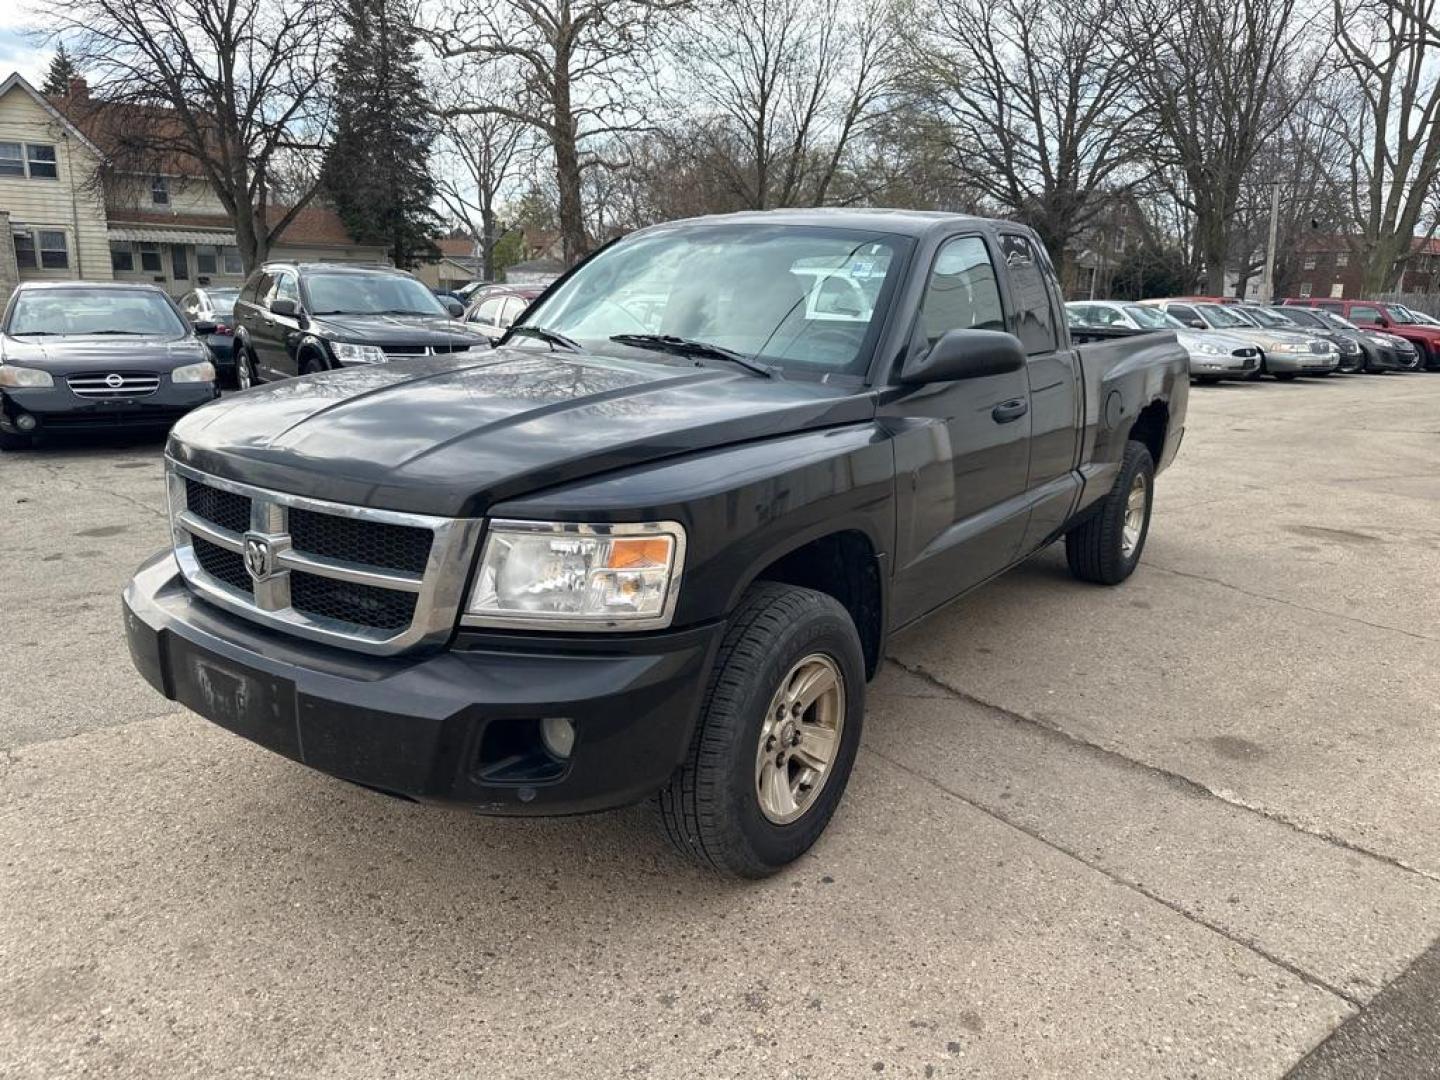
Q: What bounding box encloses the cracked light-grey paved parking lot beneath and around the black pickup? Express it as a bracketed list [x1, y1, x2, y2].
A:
[0, 374, 1440, 1080]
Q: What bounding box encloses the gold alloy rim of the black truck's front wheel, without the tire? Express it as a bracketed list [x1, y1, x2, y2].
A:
[755, 652, 845, 825]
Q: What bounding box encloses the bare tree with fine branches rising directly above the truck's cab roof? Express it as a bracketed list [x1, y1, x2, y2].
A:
[677, 0, 893, 210]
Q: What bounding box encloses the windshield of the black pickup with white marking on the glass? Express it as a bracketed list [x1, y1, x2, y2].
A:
[523, 225, 910, 374]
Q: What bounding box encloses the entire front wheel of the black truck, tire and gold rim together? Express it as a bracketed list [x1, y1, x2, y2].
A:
[657, 582, 865, 877]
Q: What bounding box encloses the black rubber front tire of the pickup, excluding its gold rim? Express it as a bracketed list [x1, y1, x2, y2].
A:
[657, 582, 865, 878]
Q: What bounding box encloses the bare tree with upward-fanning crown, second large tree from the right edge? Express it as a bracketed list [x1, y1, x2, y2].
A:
[1120, 0, 1315, 295]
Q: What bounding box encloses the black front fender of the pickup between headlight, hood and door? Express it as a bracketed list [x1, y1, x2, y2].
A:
[490, 422, 896, 626]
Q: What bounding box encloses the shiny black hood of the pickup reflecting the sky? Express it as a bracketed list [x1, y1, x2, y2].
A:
[168, 346, 874, 517]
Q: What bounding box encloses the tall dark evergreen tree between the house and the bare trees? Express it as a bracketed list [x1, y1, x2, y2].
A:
[321, 0, 441, 266]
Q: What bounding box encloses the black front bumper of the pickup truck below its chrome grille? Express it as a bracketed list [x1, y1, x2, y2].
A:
[122, 552, 724, 815]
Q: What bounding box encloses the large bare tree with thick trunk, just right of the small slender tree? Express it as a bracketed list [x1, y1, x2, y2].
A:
[428, 0, 690, 262]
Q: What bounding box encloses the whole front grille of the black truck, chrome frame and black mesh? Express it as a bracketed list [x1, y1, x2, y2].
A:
[166, 459, 481, 652]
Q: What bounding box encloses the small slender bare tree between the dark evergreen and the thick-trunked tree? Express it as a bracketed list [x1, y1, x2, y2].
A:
[435, 68, 534, 281]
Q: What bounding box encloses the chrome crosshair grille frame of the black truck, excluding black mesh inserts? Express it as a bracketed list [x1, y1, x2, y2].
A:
[166, 456, 484, 655]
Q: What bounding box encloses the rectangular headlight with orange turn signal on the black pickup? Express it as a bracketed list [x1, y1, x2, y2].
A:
[465, 521, 685, 631]
